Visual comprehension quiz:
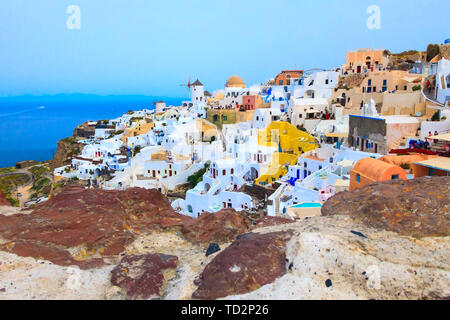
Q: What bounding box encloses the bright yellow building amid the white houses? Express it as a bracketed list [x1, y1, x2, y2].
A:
[255, 121, 317, 185]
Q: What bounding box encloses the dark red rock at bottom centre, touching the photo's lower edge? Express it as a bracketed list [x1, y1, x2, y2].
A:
[192, 232, 291, 299]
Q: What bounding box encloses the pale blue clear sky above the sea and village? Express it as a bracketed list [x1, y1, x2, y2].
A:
[0, 0, 450, 97]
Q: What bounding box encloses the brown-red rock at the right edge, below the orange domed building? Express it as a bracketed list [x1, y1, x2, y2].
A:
[322, 177, 450, 238]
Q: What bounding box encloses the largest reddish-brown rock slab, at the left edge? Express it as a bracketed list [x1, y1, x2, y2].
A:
[0, 186, 192, 268]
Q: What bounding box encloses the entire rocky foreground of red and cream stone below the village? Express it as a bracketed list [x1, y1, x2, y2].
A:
[0, 177, 450, 299]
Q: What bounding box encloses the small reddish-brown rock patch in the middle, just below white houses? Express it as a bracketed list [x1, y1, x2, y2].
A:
[183, 209, 250, 243]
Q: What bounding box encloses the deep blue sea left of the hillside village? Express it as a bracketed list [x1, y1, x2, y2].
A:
[0, 95, 182, 167]
